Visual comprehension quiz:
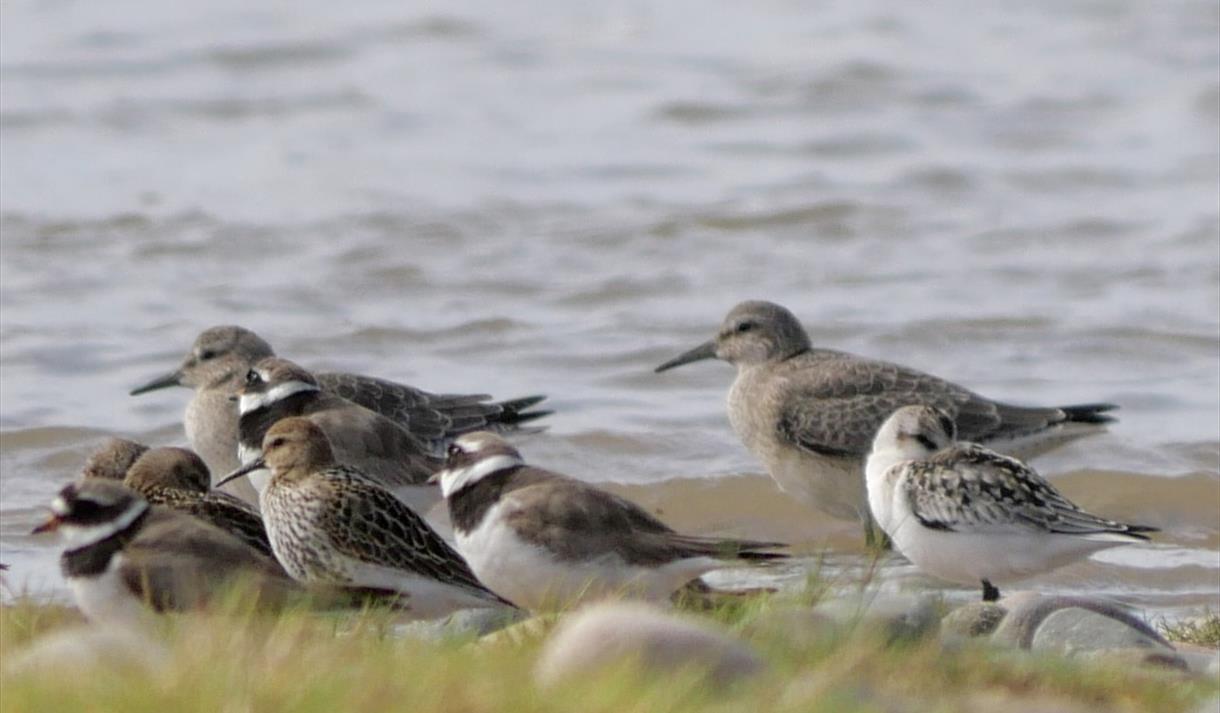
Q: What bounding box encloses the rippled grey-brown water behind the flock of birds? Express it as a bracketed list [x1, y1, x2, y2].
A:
[0, 0, 1220, 610]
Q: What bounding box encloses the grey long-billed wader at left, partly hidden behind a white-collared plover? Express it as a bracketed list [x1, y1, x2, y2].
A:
[132, 326, 550, 488]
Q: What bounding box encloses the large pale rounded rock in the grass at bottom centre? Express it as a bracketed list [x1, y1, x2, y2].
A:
[534, 602, 763, 686]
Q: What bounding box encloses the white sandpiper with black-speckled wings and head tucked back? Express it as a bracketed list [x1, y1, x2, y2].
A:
[867, 407, 1157, 602]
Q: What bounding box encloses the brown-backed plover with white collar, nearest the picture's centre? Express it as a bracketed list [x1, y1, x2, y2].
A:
[433, 432, 783, 609]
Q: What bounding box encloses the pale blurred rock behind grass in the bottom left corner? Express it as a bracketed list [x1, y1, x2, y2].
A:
[4, 625, 168, 676]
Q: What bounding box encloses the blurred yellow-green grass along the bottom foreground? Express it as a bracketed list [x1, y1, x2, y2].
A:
[0, 586, 1218, 713]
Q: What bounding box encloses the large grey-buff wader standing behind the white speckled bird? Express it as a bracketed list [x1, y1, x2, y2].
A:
[656, 302, 1116, 534]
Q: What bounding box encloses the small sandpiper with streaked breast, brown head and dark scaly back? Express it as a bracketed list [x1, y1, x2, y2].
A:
[217, 418, 508, 618]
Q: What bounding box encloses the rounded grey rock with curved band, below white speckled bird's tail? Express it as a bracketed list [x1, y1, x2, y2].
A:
[991, 592, 1174, 653]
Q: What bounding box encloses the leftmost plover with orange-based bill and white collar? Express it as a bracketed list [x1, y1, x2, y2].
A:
[34, 477, 299, 623]
